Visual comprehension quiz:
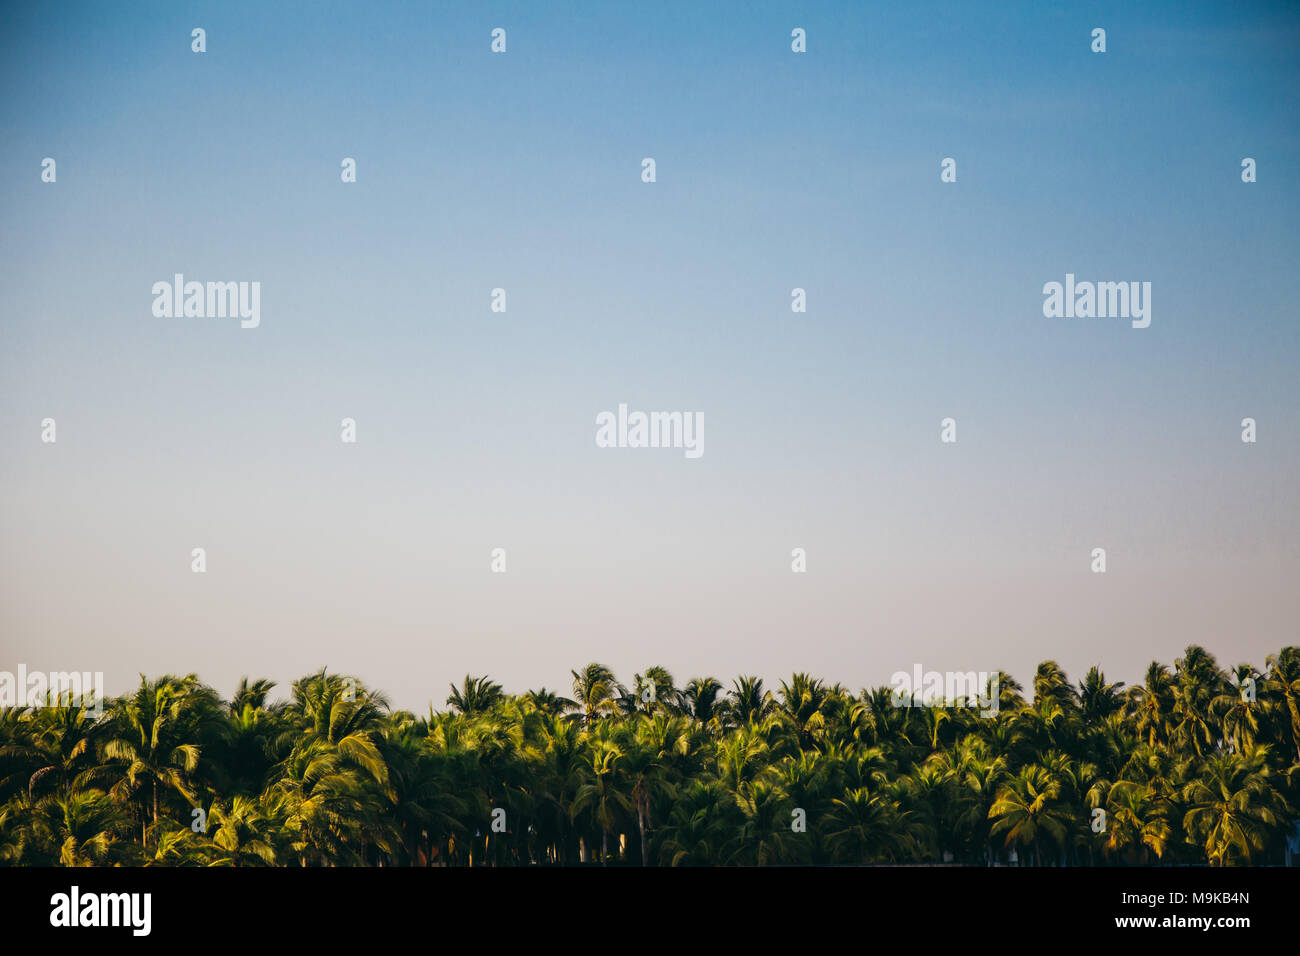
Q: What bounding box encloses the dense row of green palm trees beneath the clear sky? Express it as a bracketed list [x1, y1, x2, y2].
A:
[0, 646, 1300, 866]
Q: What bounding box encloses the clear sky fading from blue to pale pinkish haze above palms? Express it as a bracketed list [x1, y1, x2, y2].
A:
[0, 3, 1300, 710]
